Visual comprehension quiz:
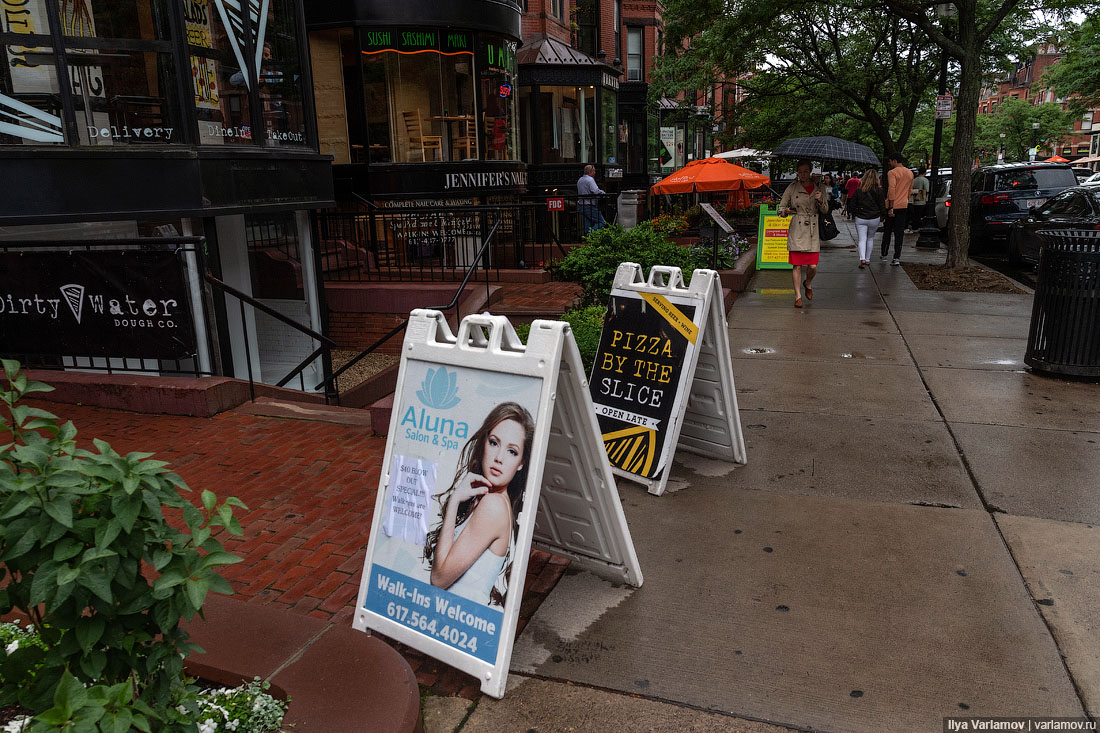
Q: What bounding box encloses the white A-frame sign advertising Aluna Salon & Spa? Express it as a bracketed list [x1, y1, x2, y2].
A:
[352, 310, 641, 698]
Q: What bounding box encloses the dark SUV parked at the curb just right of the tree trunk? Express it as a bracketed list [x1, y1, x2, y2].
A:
[970, 163, 1077, 252]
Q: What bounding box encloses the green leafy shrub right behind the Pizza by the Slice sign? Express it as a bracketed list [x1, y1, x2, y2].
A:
[558, 222, 695, 306]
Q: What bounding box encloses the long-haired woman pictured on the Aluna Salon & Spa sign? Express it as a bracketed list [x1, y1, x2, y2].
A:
[424, 402, 535, 608]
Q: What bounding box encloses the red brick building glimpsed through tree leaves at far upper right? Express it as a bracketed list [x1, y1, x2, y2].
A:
[978, 43, 1100, 161]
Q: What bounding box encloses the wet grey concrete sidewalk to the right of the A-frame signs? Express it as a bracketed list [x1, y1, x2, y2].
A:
[426, 221, 1100, 733]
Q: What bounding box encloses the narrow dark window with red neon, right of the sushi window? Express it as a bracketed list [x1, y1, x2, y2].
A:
[479, 36, 519, 161]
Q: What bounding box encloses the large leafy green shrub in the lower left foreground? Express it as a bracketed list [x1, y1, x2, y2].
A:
[0, 360, 244, 731]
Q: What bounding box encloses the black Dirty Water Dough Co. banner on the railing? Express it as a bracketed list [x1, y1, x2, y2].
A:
[0, 251, 195, 359]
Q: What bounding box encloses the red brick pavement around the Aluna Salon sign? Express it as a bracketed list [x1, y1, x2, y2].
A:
[28, 401, 569, 698]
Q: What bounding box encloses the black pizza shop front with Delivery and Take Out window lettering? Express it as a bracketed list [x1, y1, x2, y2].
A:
[0, 0, 333, 389]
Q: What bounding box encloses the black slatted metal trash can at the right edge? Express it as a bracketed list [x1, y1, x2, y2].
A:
[1024, 229, 1100, 376]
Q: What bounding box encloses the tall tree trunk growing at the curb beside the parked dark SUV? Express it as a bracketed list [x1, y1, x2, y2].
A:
[946, 44, 981, 270]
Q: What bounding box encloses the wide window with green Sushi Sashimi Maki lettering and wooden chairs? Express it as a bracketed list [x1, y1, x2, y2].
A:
[362, 30, 475, 163]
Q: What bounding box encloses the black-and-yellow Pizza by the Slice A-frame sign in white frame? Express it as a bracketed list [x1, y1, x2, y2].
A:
[591, 262, 747, 495]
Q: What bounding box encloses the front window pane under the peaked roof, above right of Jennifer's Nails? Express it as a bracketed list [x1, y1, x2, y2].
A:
[538, 87, 594, 163]
